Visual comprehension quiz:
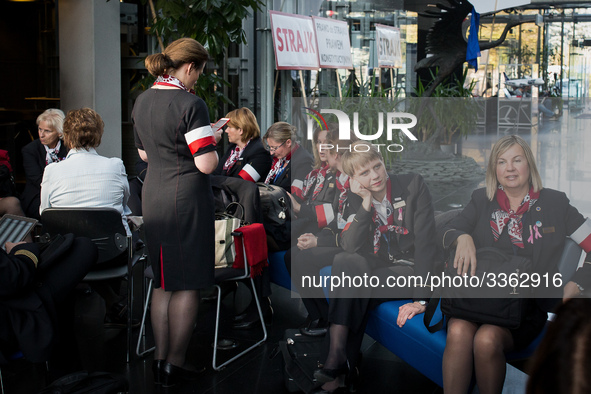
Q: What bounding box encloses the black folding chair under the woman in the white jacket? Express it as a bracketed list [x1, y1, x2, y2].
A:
[41, 208, 143, 362]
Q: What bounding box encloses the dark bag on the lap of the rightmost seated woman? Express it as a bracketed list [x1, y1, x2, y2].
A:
[424, 247, 532, 332]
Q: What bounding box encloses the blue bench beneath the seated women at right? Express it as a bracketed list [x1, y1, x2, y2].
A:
[269, 238, 581, 387]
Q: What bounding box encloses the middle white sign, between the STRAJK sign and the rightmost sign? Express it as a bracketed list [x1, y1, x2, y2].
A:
[312, 16, 353, 69]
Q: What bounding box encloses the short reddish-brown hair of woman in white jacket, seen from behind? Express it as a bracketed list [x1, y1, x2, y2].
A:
[64, 108, 105, 150]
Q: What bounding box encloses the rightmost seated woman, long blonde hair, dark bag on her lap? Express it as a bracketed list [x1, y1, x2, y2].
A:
[438, 135, 591, 393]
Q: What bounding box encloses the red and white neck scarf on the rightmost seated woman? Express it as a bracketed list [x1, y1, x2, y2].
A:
[490, 185, 540, 249]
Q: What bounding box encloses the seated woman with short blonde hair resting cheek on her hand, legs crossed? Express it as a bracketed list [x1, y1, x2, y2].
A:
[314, 141, 437, 392]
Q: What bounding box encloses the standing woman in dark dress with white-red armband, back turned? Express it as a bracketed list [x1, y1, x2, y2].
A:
[132, 38, 218, 386]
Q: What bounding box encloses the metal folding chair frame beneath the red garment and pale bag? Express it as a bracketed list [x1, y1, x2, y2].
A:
[211, 232, 267, 371]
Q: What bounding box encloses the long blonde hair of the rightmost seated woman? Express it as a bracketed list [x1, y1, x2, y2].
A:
[485, 135, 543, 201]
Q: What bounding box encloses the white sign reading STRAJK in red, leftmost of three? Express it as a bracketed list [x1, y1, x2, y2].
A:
[269, 11, 319, 70]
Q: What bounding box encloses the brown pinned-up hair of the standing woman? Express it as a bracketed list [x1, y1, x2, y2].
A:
[145, 38, 209, 77]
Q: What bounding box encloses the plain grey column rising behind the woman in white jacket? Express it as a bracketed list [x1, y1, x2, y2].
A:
[58, 0, 121, 157]
